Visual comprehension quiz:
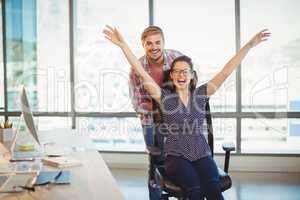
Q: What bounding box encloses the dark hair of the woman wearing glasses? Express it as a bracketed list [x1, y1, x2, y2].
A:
[162, 55, 198, 92]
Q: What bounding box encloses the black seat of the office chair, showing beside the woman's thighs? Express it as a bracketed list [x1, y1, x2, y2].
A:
[156, 166, 232, 197]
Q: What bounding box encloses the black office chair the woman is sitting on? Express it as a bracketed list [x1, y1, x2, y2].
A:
[148, 102, 235, 200]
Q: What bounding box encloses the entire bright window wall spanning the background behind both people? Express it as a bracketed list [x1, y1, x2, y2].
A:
[0, 0, 300, 154]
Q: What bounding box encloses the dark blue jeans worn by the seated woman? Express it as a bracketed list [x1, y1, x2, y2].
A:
[165, 156, 224, 200]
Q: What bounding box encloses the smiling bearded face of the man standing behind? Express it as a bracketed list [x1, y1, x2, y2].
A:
[143, 34, 164, 62]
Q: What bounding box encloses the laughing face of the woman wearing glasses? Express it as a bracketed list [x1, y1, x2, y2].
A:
[170, 61, 193, 90]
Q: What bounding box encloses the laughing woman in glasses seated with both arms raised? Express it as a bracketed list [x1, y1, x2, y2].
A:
[103, 26, 270, 200]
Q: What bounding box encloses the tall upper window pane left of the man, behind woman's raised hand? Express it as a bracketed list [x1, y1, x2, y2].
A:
[75, 0, 148, 112]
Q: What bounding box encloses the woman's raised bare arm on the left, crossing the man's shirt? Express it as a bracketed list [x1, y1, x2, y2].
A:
[103, 25, 161, 103]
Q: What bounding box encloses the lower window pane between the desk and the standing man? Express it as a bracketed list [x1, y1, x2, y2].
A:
[76, 117, 145, 152]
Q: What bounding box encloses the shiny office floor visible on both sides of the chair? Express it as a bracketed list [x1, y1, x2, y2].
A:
[111, 169, 300, 200]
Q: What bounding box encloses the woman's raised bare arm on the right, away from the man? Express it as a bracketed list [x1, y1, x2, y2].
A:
[207, 29, 271, 96]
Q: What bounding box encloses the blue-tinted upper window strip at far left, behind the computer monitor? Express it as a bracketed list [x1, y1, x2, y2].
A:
[5, 0, 38, 111]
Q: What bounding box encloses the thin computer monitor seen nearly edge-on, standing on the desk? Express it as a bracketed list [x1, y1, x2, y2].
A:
[20, 85, 40, 144]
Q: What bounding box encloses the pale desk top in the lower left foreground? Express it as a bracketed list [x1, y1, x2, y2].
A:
[1, 151, 124, 200]
